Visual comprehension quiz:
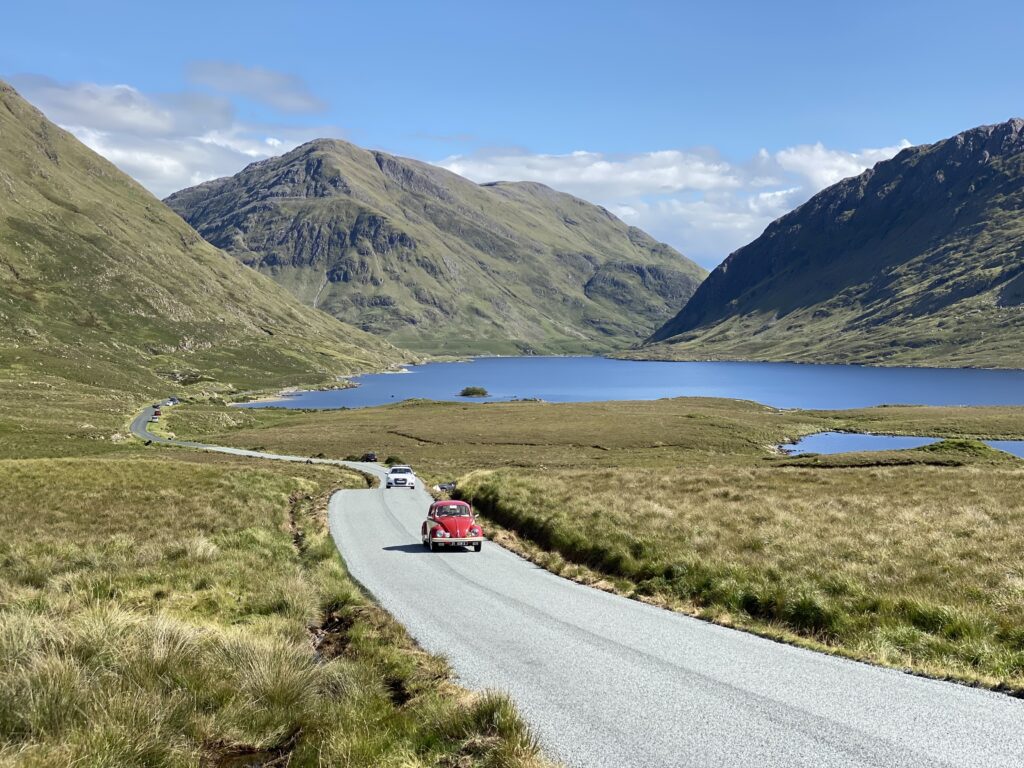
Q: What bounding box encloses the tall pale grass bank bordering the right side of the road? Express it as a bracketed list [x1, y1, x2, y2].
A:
[459, 462, 1024, 693]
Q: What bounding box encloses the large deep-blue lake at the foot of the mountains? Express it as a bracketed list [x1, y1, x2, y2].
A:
[241, 357, 1024, 409]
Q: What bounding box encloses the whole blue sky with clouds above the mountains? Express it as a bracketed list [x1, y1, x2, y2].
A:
[0, 0, 1024, 266]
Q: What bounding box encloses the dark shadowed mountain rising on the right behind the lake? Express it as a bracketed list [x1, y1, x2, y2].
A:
[637, 120, 1024, 368]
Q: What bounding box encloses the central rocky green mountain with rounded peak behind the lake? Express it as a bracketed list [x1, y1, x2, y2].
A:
[166, 139, 707, 354]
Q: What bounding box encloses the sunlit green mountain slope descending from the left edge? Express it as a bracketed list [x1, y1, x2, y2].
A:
[0, 83, 398, 392]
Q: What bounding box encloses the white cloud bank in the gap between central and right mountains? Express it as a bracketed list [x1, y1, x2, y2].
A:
[436, 140, 909, 267]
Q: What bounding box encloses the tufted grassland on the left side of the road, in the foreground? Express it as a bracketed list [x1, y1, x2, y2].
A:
[0, 460, 543, 766]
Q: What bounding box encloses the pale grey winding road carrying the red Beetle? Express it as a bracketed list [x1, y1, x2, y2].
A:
[132, 410, 1024, 768]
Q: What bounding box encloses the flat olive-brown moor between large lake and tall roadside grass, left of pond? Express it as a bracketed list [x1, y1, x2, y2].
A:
[166, 398, 815, 479]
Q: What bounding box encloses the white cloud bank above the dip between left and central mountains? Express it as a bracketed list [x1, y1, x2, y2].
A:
[11, 75, 339, 198]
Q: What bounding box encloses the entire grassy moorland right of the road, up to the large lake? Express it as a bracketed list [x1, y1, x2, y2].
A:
[167, 398, 1024, 691]
